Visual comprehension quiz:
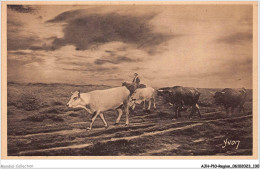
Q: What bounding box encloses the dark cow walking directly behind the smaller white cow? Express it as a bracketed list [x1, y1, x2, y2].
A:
[158, 86, 201, 119]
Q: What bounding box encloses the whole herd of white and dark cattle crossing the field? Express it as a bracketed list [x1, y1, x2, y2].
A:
[67, 82, 246, 130]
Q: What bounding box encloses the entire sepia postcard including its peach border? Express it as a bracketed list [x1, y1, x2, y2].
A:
[2, 2, 258, 159]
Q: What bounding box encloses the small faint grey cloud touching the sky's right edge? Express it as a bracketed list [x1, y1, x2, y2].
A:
[217, 32, 253, 44]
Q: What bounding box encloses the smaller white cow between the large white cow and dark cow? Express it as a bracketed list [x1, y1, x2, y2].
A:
[129, 87, 156, 110]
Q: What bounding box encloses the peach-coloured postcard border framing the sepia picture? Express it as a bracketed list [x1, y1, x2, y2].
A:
[1, 1, 258, 160]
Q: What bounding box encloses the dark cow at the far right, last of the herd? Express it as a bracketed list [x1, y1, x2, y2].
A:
[213, 88, 247, 116]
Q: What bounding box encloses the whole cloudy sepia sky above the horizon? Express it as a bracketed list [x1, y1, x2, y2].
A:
[7, 5, 253, 88]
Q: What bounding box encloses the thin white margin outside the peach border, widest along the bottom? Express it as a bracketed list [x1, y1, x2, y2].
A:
[0, 0, 260, 169]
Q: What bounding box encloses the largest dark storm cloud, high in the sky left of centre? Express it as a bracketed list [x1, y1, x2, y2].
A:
[47, 10, 173, 50]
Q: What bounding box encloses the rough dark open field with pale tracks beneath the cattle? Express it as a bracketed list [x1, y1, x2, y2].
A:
[7, 83, 253, 156]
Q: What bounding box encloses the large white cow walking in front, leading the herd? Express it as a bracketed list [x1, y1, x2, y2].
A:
[67, 87, 130, 130]
